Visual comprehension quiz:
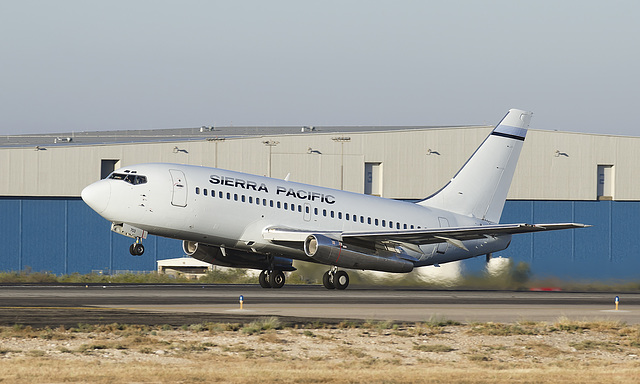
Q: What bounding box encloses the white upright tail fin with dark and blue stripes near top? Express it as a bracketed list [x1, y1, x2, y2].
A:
[418, 109, 533, 223]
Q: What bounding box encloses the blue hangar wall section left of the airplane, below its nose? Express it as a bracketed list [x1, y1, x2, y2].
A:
[0, 198, 183, 274]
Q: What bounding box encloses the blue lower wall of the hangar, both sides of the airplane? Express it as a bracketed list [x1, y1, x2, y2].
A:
[0, 198, 640, 280]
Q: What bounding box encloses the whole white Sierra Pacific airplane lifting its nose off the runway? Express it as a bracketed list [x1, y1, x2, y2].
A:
[81, 109, 588, 290]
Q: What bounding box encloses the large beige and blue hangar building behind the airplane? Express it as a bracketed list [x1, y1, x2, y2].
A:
[0, 126, 640, 280]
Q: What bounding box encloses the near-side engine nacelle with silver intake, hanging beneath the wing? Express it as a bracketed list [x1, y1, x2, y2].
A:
[304, 235, 413, 273]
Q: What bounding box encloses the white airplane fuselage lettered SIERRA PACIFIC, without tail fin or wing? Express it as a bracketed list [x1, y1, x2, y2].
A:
[83, 163, 511, 267]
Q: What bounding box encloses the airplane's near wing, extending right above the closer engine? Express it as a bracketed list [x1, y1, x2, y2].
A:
[262, 223, 590, 248]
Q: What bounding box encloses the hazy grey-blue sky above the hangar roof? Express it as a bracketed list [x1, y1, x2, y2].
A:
[0, 0, 640, 136]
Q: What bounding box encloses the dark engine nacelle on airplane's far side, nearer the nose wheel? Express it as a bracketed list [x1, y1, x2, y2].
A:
[182, 240, 296, 272]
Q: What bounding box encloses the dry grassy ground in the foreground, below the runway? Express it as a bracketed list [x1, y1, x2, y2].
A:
[0, 318, 640, 383]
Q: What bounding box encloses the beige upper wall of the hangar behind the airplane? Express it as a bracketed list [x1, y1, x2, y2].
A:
[0, 127, 640, 200]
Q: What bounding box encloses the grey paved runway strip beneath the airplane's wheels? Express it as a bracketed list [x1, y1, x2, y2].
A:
[0, 285, 640, 327]
